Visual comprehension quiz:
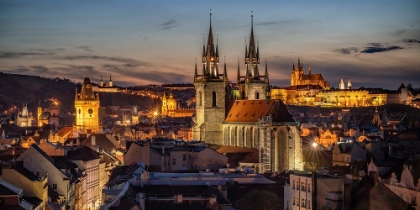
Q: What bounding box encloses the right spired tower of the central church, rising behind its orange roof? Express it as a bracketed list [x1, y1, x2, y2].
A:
[238, 15, 269, 99]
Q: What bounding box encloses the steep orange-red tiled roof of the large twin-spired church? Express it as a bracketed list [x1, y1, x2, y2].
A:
[224, 99, 295, 123]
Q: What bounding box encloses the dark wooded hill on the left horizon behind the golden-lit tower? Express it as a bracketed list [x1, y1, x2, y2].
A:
[0, 72, 159, 118]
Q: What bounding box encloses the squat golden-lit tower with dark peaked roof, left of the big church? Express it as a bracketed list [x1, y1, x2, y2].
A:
[74, 77, 101, 133]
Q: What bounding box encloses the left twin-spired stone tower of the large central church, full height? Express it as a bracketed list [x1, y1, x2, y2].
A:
[193, 13, 230, 145]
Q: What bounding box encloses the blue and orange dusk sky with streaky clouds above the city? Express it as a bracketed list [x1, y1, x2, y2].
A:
[0, 0, 420, 89]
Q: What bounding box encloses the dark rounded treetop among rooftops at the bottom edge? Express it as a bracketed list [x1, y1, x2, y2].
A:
[236, 189, 283, 210]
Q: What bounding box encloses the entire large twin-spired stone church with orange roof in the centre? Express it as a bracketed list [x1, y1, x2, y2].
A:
[193, 14, 303, 173]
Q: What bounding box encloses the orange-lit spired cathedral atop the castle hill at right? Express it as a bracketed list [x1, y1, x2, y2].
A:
[290, 59, 330, 90]
